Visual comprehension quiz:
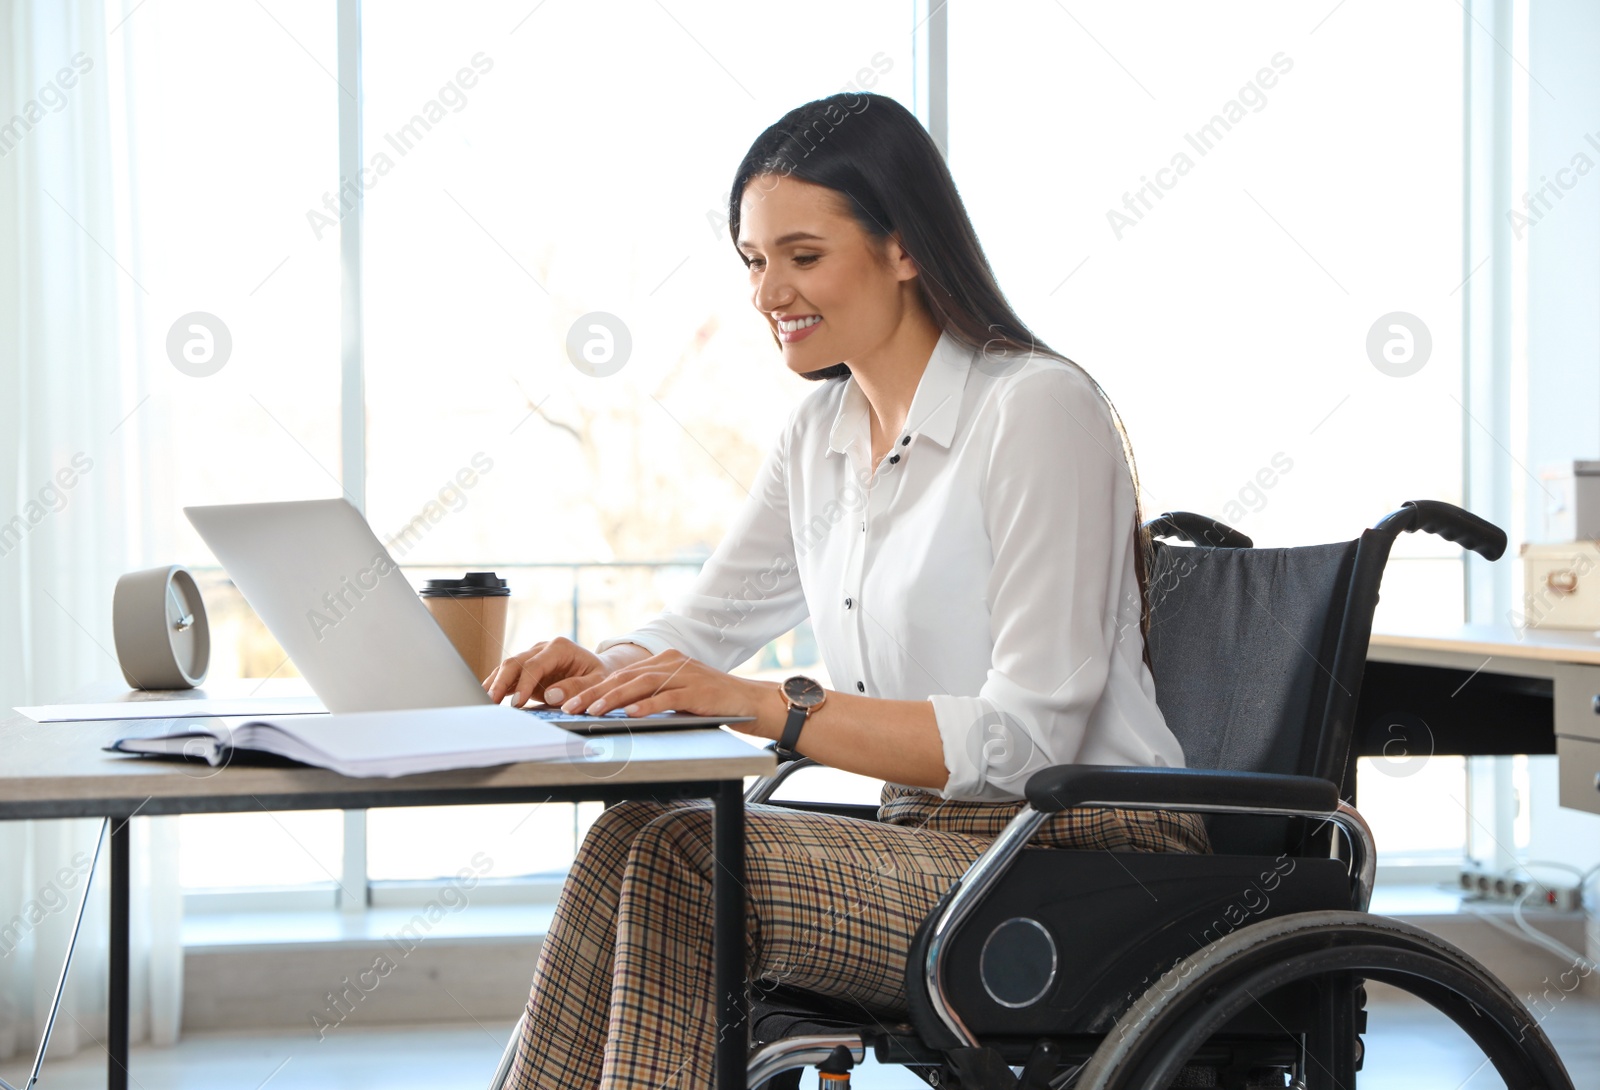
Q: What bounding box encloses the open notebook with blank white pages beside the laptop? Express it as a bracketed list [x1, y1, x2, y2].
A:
[106, 704, 592, 776]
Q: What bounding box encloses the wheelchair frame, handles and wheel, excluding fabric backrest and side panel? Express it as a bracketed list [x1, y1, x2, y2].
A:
[491, 501, 1571, 1090]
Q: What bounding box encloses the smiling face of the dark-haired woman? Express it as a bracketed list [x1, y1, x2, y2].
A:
[739, 174, 920, 373]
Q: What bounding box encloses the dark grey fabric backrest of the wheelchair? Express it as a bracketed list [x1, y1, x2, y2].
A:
[1147, 539, 1360, 852]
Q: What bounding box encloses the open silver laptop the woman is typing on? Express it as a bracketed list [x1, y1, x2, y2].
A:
[184, 499, 752, 733]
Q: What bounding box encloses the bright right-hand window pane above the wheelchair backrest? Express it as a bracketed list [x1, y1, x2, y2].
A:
[949, 2, 1467, 860]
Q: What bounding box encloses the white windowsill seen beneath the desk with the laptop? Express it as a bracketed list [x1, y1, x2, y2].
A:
[182, 904, 555, 954]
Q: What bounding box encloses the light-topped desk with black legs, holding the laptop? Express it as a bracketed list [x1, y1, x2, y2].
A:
[0, 704, 778, 1090]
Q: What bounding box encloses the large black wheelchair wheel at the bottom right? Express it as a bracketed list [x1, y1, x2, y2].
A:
[1072, 912, 1573, 1090]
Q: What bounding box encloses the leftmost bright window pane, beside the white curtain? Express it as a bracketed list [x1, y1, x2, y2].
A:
[107, 0, 344, 887]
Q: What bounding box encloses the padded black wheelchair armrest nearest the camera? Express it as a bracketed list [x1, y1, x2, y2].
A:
[1024, 765, 1339, 813]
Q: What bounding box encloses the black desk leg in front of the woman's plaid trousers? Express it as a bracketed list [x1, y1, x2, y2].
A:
[712, 779, 750, 1090]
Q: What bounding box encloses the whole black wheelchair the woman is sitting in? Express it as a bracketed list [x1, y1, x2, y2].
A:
[491, 499, 1573, 1090]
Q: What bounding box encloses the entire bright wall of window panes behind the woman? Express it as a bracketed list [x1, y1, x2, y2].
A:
[112, 0, 1464, 896]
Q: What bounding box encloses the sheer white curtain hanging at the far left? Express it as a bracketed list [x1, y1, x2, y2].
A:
[0, 0, 182, 1082]
